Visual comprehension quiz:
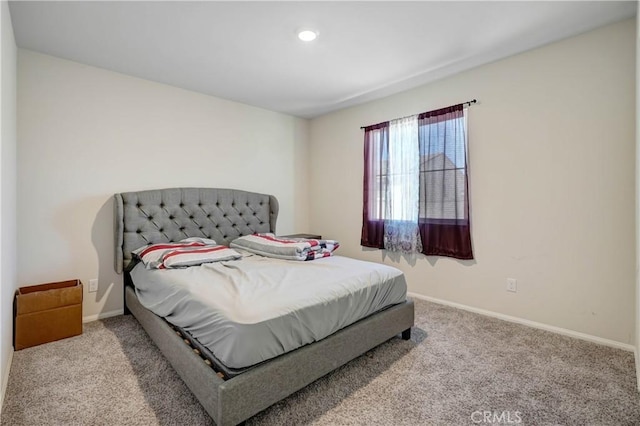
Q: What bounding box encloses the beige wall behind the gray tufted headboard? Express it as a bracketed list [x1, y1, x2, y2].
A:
[18, 50, 308, 318]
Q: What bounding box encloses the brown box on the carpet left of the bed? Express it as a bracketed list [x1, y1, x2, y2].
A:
[13, 280, 82, 350]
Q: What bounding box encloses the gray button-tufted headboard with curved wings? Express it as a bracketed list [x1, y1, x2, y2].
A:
[114, 188, 278, 273]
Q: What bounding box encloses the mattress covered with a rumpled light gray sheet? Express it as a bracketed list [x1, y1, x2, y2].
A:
[131, 252, 407, 369]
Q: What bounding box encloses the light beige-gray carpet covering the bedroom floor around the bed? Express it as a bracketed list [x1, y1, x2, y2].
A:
[2, 300, 640, 425]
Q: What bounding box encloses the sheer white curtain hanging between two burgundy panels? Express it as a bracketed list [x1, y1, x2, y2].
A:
[384, 115, 422, 253]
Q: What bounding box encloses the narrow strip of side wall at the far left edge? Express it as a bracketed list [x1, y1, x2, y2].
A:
[0, 1, 17, 409]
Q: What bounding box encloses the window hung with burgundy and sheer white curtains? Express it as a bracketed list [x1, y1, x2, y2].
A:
[361, 105, 473, 259]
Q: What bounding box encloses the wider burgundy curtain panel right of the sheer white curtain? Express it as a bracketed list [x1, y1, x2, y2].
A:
[418, 104, 473, 259]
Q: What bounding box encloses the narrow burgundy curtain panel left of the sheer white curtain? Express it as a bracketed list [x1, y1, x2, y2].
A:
[360, 122, 389, 248]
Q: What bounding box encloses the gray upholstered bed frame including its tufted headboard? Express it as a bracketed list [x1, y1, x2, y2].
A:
[115, 188, 414, 426]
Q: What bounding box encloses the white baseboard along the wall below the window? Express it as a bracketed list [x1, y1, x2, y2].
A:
[407, 292, 640, 352]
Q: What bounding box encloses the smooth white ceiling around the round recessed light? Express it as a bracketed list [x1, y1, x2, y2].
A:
[10, 1, 637, 117]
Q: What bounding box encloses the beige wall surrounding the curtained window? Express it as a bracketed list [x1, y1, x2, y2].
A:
[310, 20, 636, 344]
